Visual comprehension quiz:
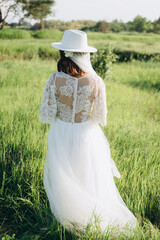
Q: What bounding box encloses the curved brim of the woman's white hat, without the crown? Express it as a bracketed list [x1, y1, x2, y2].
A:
[51, 43, 97, 52]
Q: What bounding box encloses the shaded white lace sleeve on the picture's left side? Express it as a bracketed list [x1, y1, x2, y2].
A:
[40, 74, 57, 124]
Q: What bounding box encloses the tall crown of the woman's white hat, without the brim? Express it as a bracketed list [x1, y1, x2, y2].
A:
[62, 30, 88, 49]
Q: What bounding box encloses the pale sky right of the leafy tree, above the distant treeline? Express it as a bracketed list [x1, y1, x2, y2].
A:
[48, 0, 160, 22]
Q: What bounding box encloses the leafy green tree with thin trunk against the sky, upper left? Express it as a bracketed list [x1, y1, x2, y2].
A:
[18, 0, 55, 29]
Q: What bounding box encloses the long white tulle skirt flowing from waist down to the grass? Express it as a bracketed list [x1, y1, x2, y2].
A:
[44, 119, 136, 233]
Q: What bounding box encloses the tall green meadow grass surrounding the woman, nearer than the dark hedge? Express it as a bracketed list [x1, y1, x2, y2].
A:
[0, 59, 160, 240]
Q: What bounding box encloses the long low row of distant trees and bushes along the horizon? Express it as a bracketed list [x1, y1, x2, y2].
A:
[41, 15, 160, 33]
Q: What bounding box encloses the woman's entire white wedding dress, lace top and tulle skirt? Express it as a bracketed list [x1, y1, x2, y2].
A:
[40, 72, 136, 230]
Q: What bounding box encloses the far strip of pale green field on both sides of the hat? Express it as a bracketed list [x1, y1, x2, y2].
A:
[0, 29, 160, 60]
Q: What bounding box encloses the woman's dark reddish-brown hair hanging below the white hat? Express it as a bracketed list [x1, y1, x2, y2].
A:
[57, 50, 85, 77]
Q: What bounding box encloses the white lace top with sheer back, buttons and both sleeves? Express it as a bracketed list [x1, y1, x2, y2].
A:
[40, 72, 107, 126]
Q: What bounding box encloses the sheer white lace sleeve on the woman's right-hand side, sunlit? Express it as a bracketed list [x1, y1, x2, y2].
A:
[92, 77, 107, 126]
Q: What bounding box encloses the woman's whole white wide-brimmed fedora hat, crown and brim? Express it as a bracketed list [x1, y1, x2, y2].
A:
[51, 30, 97, 52]
